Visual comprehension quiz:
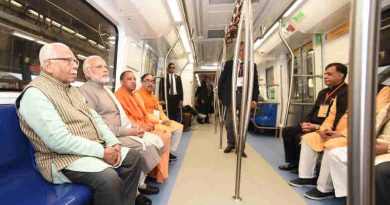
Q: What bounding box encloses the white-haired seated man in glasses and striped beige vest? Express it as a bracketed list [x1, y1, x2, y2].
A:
[16, 43, 141, 205]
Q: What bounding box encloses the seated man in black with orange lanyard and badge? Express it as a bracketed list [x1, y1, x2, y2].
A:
[279, 63, 348, 172]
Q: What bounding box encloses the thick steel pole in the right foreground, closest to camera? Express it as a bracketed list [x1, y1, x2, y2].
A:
[347, 0, 380, 205]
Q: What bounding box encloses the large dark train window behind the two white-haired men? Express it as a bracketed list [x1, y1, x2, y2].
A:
[0, 0, 118, 91]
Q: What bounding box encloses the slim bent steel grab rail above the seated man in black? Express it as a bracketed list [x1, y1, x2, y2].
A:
[279, 20, 295, 137]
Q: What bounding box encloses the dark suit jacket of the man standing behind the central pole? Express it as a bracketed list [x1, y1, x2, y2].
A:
[218, 60, 260, 105]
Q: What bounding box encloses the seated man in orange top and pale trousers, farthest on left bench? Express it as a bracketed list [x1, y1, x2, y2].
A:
[134, 73, 183, 162]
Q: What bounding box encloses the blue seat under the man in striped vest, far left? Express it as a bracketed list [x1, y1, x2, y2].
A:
[0, 105, 92, 205]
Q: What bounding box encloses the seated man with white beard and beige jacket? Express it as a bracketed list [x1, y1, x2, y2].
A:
[80, 56, 165, 204]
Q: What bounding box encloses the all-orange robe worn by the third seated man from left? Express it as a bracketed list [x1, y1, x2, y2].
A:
[115, 86, 171, 183]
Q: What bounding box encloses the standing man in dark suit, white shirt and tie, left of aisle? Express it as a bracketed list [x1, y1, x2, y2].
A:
[160, 63, 183, 121]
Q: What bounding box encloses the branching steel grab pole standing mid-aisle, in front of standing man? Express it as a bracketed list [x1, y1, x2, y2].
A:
[232, 0, 250, 201]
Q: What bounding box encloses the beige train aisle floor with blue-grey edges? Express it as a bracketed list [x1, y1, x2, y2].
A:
[148, 120, 345, 205]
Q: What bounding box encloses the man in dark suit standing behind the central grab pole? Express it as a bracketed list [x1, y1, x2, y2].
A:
[218, 42, 259, 157]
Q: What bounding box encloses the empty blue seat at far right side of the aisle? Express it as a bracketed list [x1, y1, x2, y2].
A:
[255, 104, 278, 127]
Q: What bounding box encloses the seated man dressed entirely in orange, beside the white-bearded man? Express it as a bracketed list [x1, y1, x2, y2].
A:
[115, 71, 171, 183]
